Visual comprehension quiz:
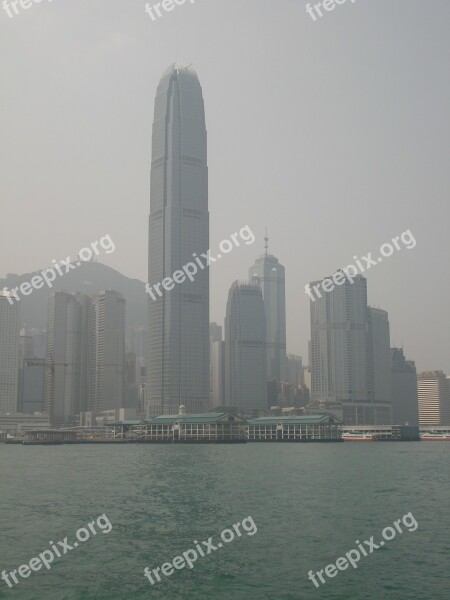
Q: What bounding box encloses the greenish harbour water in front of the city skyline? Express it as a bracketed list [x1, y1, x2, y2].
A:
[0, 442, 450, 600]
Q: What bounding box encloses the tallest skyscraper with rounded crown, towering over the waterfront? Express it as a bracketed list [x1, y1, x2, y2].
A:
[146, 64, 210, 415]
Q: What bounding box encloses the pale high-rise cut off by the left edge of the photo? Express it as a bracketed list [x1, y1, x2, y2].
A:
[0, 291, 20, 413]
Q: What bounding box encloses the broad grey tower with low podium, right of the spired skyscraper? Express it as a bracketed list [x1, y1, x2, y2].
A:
[310, 275, 378, 425]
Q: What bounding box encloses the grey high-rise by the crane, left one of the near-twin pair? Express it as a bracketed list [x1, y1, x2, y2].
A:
[44, 292, 86, 426]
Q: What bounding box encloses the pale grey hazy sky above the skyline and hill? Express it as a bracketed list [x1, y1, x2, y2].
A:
[0, 0, 450, 374]
